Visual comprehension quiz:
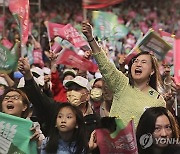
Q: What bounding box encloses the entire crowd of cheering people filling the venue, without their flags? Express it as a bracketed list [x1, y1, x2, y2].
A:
[0, 0, 180, 154]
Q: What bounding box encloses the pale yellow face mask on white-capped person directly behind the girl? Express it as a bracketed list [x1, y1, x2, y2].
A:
[67, 90, 84, 106]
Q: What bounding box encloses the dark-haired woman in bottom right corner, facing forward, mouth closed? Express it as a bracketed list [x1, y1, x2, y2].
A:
[136, 107, 180, 154]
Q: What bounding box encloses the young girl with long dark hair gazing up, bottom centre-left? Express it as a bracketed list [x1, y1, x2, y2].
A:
[41, 103, 88, 154]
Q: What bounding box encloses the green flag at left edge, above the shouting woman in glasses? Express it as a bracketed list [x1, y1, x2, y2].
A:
[0, 43, 19, 73]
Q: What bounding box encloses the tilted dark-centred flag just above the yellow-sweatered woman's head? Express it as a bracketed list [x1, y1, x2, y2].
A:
[128, 29, 172, 61]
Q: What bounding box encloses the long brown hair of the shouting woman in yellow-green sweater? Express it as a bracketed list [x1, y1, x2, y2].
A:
[128, 51, 162, 90]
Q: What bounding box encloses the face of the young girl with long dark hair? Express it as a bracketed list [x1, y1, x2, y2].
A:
[56, 107, 76, 132]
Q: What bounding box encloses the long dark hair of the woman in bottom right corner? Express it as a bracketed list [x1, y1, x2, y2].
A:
[136, 107, 179, 154]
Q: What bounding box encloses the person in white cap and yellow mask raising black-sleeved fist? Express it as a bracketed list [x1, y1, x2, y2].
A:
[18, 57, 99, 151]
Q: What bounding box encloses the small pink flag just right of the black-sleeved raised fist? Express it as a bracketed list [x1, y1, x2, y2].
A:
[33, 49, 44, 67]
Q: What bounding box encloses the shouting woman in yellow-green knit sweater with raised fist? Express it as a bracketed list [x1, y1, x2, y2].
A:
[82, 21, 166, 126]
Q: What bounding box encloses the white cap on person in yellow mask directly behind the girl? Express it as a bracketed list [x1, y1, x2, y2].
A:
[65, 76, 90, 90]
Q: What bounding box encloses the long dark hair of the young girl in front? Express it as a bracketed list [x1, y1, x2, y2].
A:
[46, 103, 88, 154]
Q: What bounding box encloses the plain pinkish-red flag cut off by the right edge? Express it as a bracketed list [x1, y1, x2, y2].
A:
[174, 39, 180, 83]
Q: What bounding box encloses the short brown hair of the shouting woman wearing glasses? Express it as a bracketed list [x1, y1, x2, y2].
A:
[1, 88, 31, 118]
